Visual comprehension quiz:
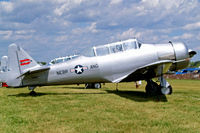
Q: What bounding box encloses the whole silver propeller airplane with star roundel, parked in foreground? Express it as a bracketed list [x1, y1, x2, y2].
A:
[0, 39, 196, 95]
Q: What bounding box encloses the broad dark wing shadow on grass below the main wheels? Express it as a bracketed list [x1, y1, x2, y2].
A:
[106, 90, 168, 102]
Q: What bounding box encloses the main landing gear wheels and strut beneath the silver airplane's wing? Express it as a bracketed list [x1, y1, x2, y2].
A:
[145, 76, 172, 96]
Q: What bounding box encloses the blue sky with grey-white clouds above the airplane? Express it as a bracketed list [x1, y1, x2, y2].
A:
[0, 0, 200, 62]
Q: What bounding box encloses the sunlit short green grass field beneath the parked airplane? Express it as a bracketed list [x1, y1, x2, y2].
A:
[0, 80, 200, 133]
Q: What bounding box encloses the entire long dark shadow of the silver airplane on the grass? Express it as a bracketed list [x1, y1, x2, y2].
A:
[8, 90, 168, 102]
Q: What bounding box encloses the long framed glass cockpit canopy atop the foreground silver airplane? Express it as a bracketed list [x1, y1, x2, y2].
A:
[93, 39, 141, 56]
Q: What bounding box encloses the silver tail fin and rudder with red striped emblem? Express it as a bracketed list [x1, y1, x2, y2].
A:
[6, 44, 40, 87]
